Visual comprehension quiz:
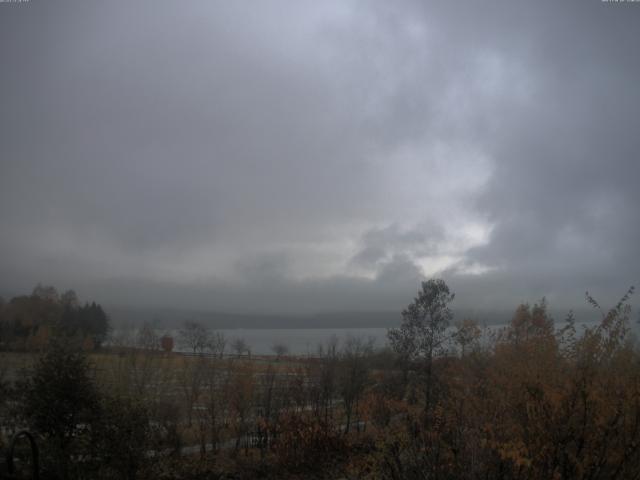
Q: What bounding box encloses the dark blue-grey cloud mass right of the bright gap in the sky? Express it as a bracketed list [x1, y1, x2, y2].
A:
[438, 2, 640, 308]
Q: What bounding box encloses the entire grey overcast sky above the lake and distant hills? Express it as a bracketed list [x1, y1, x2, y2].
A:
[0, 0, 640, 313]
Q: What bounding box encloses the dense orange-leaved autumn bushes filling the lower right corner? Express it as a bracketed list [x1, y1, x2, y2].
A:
[362, 289, 640, 480]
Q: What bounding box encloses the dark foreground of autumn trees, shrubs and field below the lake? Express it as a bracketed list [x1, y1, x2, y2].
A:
[0, 280, 640, 480]
